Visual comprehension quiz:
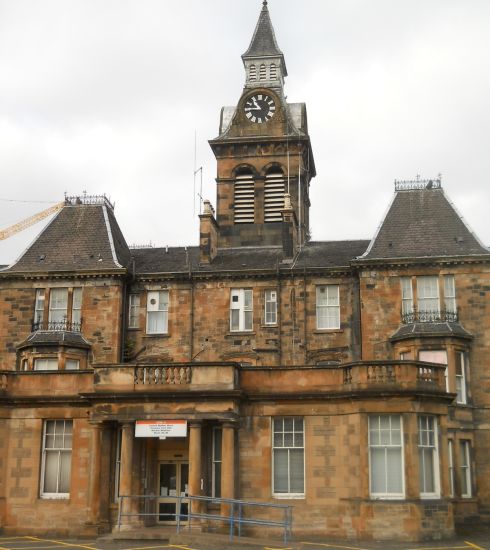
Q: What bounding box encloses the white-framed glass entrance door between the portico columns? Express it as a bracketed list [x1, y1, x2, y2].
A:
[158, 462, 189, 523]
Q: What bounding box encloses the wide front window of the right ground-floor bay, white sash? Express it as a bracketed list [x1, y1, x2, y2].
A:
[368, 414, 405, 500]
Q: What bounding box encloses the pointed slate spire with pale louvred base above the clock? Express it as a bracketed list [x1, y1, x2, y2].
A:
[242, 0, 288, 89]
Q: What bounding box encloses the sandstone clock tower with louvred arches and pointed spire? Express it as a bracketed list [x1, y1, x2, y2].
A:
[209, 1, 315, 257]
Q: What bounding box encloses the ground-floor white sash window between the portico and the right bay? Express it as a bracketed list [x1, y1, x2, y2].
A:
[271, 416, 306, 498]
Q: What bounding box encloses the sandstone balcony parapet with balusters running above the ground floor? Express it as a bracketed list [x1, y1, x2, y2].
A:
[0, 361, 446, 399]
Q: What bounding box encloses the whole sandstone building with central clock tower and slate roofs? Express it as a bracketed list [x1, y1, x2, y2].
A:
[0, 2, 490, 540]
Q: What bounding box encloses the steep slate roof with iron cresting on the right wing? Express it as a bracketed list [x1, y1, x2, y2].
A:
[360, 188, 490, 259]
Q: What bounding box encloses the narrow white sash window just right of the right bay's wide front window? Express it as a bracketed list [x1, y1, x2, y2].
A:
[418, 415, 441, 498]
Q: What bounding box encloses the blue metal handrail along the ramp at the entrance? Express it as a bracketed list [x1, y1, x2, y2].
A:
[117, 495, 293, 543]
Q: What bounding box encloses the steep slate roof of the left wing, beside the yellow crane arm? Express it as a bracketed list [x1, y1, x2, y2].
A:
[4, 197, 131, 273]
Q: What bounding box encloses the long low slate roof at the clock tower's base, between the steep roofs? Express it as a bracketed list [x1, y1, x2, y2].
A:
[132, 240, 369, 274]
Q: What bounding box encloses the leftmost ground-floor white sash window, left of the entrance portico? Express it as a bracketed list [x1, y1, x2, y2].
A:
[40, 419, 73, 499]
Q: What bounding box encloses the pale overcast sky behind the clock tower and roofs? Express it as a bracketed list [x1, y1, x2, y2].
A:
[0, 0, 490, 263]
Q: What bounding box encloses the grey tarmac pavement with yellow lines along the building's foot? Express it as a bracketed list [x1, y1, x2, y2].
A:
[0, 528, 490, 550]
